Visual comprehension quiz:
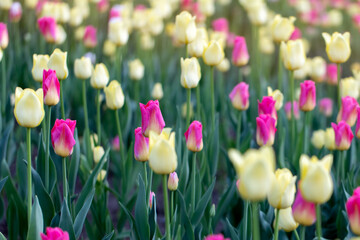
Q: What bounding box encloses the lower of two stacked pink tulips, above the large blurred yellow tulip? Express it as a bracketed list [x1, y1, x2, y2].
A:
[256, 114, 276, 146]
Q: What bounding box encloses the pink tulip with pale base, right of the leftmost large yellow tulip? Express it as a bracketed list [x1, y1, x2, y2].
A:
[51, 119, 76, 157]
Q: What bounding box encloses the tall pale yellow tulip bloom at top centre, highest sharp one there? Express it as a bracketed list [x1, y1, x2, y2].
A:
[175, 11, 196, 44]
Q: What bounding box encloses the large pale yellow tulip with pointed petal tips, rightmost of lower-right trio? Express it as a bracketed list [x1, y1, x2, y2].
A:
[299, 154, 334, 204]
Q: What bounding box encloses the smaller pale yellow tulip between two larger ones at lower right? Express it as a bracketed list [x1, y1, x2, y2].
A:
[268, 168, 296, 209]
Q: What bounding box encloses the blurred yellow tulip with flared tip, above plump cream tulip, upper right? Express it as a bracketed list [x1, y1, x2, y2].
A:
[270, 14, 296, 43]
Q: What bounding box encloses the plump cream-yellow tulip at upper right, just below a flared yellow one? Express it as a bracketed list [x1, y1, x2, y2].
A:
[280, 39, 306, 71]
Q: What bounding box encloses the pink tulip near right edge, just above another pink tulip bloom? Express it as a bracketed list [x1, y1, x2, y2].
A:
[336, 96, 359, 127]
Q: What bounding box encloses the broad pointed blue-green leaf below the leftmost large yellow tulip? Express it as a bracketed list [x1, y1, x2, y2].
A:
[26, 196, 44, 240]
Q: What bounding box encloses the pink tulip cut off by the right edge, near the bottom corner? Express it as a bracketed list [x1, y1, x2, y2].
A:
[346, 187, 360, 235]
